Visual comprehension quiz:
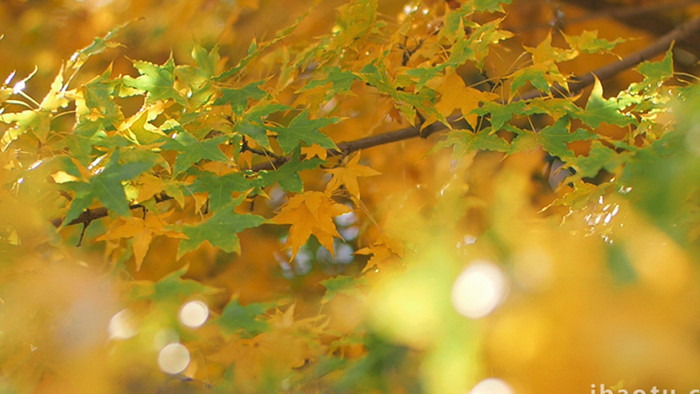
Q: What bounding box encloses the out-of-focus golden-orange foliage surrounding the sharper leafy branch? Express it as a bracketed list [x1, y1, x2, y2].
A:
[0, 0, 700, 394]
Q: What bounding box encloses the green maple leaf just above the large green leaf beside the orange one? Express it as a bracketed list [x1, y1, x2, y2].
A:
[188, 171, 255, 212]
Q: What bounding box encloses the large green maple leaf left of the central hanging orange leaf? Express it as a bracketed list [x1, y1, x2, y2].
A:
[177, 195, 265, 259]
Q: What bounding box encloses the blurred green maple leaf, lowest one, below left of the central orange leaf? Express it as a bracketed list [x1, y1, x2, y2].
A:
[217, 299, 277, 337]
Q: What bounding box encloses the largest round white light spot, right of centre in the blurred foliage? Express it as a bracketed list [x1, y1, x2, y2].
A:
[452, 261, 507, 319]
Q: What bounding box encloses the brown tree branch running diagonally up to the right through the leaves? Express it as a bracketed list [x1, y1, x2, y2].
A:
[51, 16, 700, 227]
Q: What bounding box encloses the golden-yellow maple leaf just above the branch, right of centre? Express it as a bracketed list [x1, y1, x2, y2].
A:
[424, 71, 499, 125]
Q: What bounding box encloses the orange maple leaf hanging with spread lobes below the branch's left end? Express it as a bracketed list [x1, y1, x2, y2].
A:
[96, 211, 185, 271]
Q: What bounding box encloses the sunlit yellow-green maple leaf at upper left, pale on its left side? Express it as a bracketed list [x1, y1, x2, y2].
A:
[122, 57, 187, 106]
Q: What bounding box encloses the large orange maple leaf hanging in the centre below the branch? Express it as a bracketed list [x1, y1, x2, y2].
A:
[271, 191, 351, 260]
